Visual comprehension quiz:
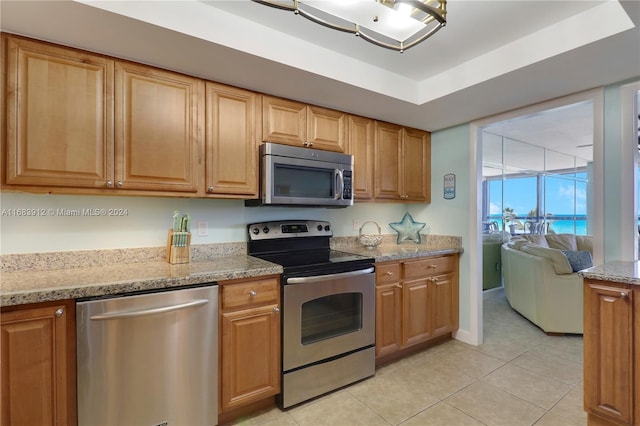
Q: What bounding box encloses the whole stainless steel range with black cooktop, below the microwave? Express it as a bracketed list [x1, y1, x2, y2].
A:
[247, 220, 375, 408]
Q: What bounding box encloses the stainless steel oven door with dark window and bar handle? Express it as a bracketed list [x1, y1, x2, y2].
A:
[282, 268, 375, 372]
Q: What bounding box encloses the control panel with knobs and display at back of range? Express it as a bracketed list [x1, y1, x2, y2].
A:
[247, 220, 333, 240]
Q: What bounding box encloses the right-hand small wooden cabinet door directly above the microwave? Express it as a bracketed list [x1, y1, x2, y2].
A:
[306, 105, 349, 152]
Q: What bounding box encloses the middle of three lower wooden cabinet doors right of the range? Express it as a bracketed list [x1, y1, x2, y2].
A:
[402, 278, 433, 346]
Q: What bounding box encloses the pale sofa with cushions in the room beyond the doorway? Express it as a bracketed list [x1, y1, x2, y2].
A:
[500, 234, 593, 334]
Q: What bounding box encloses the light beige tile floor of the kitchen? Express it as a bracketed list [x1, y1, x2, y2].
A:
[225, 290, 587, 426]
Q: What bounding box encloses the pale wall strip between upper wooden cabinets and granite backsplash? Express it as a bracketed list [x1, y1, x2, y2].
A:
[0, 192, 416, 254]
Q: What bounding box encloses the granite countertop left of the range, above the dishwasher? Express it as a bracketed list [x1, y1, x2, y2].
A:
[0, 255, 282, 306]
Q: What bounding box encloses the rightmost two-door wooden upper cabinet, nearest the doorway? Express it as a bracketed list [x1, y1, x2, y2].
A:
[375, 122, 431, 203]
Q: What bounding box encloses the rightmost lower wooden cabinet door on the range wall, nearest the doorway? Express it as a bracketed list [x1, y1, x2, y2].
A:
[430, 273, 458, 336]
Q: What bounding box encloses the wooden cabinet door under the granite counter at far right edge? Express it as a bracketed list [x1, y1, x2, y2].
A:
[584, 280, 633, 424]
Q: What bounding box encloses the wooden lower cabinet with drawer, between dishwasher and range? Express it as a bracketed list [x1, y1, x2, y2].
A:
[219, 277, 281, 413]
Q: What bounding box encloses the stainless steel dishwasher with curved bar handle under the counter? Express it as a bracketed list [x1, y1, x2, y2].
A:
[76, 283, 218, 426]
